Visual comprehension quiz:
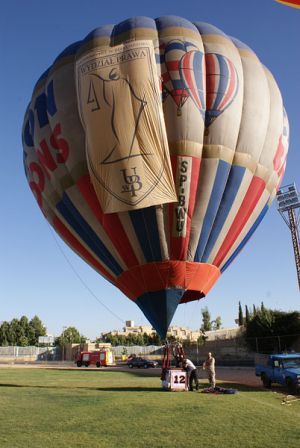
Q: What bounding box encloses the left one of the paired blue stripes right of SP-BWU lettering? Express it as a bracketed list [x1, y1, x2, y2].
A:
[194, 160, 231, 262]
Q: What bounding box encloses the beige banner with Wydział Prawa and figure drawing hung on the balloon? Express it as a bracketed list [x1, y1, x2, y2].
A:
[76, 41, 177, 213]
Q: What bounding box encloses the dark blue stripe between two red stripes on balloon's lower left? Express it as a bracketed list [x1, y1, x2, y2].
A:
[56, 193, 123, 276]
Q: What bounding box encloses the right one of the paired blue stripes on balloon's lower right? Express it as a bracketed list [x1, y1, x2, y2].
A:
[202, 165, 246, 263]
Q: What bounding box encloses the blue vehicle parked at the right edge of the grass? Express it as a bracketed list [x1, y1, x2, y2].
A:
[255, 353, 300, 394]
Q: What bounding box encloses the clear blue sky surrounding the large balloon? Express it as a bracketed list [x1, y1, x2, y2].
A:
[0, 0, 300, 338]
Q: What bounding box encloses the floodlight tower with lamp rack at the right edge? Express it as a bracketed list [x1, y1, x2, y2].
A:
[276, 183, 300, 289]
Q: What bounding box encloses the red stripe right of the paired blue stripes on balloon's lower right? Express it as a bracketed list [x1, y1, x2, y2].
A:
[213, 176, 265, 266]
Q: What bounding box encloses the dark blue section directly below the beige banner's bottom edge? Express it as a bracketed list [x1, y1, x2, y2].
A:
[129, 207, 161, 262]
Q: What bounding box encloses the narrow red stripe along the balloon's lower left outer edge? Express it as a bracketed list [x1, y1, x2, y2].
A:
[52, 216, 116, 284]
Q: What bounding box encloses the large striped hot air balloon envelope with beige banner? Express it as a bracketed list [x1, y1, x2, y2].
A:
[22, 16, 288, 337]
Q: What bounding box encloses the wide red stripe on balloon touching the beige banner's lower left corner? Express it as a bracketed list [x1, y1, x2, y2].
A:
[77, 175, 138, 268]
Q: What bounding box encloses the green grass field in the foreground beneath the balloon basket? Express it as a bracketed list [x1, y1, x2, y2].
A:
[0, 368, 300, 448]
